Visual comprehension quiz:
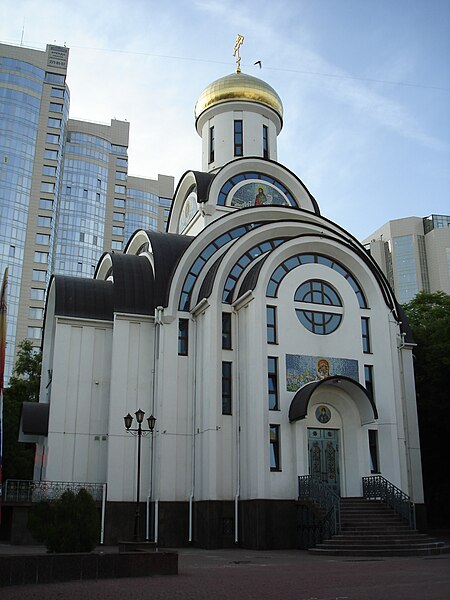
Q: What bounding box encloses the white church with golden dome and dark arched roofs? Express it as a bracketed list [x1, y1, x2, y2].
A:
[24, 61, 423, 549]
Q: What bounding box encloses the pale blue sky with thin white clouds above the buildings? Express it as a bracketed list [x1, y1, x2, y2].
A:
[0, 0, 450, 240]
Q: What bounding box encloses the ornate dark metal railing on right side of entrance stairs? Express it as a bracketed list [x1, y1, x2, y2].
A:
[362, 475, 416, 529]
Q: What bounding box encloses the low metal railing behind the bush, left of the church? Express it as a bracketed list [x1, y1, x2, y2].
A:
[3, 479, 104, 504]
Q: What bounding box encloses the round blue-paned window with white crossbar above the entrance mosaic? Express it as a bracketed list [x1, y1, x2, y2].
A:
[294, 279, 342, 335]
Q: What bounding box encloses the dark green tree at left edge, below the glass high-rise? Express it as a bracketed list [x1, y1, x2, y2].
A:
[3, 340, 41, 481]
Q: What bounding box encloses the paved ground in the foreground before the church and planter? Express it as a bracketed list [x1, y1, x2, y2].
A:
[0, 544, 450, 600]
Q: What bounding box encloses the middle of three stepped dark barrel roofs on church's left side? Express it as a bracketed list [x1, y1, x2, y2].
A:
[111, 253, 155, 315]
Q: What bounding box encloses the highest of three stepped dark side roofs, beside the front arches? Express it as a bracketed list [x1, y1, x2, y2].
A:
[146, 231, 194, 307]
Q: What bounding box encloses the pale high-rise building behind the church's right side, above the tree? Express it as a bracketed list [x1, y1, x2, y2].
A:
[363, 215, 450, 304]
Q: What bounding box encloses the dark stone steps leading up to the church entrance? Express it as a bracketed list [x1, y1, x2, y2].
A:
[310, 498, 450, 557]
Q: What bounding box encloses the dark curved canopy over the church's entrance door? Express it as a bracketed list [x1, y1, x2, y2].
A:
[289, 375, 378, 425]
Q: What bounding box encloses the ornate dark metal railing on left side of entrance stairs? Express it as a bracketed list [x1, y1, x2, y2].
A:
[298, 475, 341, 535]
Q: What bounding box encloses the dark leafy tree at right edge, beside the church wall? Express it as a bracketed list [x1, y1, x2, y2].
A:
[403, 292, 450, 526]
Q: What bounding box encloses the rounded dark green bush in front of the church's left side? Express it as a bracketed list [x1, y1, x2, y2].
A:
[28, 489, 100, 552]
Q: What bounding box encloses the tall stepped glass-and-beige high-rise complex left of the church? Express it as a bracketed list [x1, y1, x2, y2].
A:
[0, 44, 173, 381]
